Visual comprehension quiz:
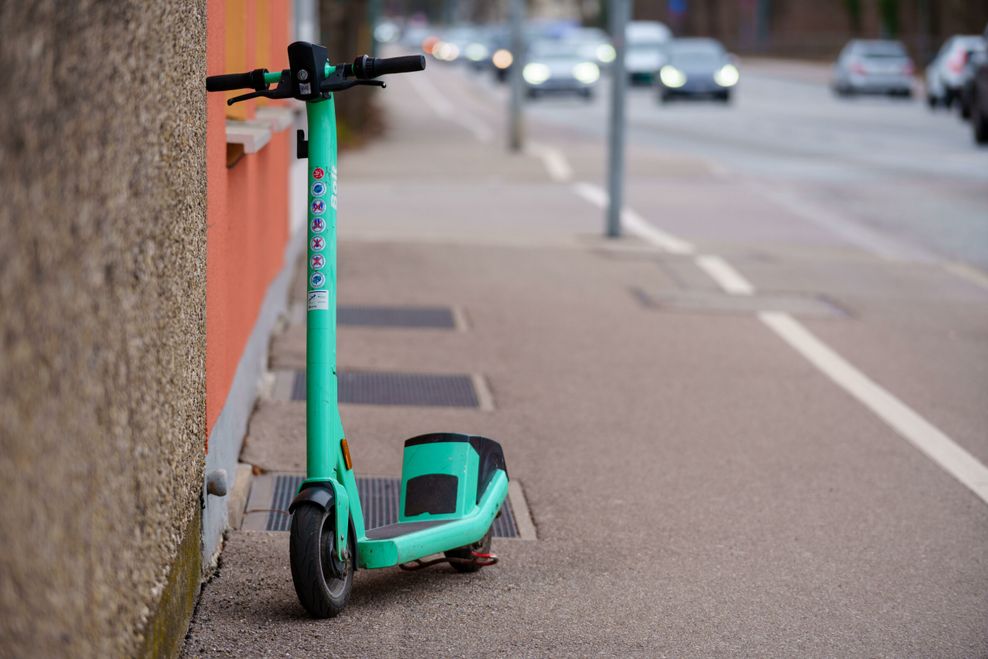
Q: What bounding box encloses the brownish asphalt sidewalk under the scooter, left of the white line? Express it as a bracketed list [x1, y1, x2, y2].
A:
[184, 64, 988, 656]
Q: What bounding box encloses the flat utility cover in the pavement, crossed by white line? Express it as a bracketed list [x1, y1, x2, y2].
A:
[632, 289, 848, 318]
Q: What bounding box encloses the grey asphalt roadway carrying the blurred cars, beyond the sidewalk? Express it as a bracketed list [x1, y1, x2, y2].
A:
[532, 65, 988, 269]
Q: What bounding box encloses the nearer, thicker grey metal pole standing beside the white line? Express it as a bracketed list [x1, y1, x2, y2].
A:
[607, 0, 632, 238]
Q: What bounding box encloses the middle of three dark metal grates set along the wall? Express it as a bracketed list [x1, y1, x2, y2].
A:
[292, 371, 480, 407]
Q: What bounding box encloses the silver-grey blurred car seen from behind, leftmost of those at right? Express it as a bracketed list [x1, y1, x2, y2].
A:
[834, 39, 916, 96]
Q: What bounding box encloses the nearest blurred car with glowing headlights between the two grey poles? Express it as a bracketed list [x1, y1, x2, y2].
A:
[521, 39, 600, 100]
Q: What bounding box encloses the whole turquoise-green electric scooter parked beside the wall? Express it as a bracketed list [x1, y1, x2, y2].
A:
[206, 42, 508, 618]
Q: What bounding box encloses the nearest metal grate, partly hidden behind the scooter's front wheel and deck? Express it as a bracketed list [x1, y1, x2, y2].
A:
[265, 474, 519, 538]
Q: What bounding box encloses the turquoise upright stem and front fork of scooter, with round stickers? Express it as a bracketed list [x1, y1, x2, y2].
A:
[302, 95, 364, 560]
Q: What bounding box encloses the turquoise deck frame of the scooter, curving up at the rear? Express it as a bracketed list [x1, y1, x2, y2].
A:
[357, 469, 508, 568]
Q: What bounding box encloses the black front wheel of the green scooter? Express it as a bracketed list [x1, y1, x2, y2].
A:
[289, 505, 357, 618]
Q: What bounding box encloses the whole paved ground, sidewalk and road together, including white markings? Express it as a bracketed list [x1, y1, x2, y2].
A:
[185, 59, 988, 657]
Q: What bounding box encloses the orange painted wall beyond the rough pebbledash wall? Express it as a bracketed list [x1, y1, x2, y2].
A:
[206, 0, 292, 436]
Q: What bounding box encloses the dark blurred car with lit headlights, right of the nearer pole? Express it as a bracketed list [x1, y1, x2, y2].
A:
[657, 39, 741, 103]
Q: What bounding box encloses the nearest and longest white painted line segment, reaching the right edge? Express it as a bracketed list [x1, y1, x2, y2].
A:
[758, 311, 988, 503]
